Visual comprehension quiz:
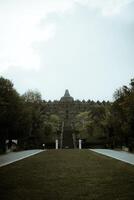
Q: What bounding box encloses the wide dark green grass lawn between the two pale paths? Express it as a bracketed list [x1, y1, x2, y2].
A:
[0, 150, 134, 200]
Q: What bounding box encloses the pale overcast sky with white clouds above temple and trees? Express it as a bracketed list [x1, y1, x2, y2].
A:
[0, 0, 134, 101]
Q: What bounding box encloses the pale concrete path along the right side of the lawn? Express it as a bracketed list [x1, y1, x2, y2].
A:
[90, 149, 134, 165]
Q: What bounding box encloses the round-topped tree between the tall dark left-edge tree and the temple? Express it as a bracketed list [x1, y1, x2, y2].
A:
[22, 90, 44, 148]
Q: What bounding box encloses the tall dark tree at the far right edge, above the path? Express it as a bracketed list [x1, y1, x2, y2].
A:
[109, 79, 134, 148]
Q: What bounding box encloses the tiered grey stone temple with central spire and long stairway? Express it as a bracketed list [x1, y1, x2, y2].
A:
[44, 89, 107, 148]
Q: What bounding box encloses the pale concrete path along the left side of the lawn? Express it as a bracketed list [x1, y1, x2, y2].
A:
[0, 149, 44, 167]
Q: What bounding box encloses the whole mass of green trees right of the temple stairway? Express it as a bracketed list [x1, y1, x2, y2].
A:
[75, 79, 134, 151]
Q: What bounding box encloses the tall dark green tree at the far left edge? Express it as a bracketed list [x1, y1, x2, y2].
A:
[0, 77, 21, 151]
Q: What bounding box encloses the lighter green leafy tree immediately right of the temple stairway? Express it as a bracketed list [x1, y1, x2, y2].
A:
[75, 105, 106, 141]
